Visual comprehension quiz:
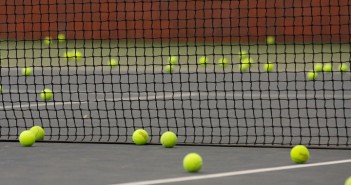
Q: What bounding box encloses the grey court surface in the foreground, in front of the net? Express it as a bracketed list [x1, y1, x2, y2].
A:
[0, 143, 350, 185]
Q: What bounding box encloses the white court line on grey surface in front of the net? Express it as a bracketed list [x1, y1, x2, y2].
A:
[111, 159, 351, 185]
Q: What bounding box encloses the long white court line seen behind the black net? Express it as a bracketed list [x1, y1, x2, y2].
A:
[0, 92, 351, 110]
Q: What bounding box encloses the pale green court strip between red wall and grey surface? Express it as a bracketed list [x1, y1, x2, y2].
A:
[0, 40, 351, 73]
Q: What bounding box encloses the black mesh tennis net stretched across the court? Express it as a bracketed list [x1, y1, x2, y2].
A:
[0, 0, 351, 147]
